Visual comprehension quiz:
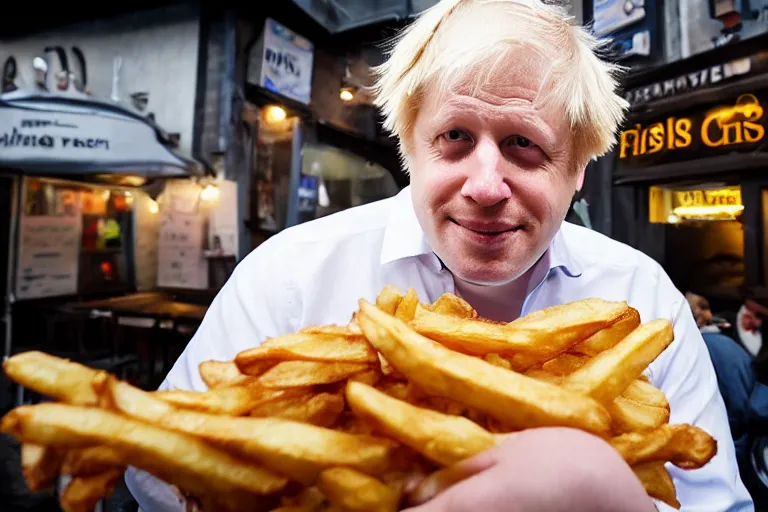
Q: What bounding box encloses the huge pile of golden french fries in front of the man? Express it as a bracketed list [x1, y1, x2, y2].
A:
[1, 286, 717, 512]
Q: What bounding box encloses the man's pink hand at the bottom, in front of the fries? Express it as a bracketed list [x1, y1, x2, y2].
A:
[402, 428, 656, 512]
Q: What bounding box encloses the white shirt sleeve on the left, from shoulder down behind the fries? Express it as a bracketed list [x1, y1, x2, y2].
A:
[125, 242, 301, 512]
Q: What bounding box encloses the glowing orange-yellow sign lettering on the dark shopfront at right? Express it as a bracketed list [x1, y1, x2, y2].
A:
[619, 94, 766, 160]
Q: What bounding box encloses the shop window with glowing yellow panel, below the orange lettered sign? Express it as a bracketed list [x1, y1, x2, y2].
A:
[649, 185, 744, 294]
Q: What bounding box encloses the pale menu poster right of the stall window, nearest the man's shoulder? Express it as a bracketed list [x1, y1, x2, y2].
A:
[157, 211, 208, 289]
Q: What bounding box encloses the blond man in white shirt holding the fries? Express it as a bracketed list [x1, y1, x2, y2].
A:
[127, 0, 752, 512]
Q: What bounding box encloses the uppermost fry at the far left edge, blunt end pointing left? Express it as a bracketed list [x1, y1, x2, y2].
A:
[3, 351, 99, 405]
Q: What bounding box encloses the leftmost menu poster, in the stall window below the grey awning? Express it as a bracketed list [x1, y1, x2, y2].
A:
[16, 215, 82, 299]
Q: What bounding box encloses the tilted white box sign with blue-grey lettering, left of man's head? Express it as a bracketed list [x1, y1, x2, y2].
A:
[259, 19, 314, 104]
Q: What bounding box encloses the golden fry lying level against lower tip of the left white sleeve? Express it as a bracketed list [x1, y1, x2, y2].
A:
[154, 387, 263, 416]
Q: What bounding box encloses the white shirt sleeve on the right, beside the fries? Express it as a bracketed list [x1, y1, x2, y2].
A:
[650, 286, 754, 512]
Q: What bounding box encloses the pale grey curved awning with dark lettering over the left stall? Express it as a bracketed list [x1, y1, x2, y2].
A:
[0, 91, 205, 186]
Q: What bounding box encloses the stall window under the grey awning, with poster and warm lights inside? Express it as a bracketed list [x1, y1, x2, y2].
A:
[16, 179, 133, 299]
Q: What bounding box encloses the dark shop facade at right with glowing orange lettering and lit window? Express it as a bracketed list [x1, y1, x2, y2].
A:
[598, 38, 768, 301]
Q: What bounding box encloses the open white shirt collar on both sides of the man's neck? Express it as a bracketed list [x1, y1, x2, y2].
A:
[381, 185, 581, 277]
